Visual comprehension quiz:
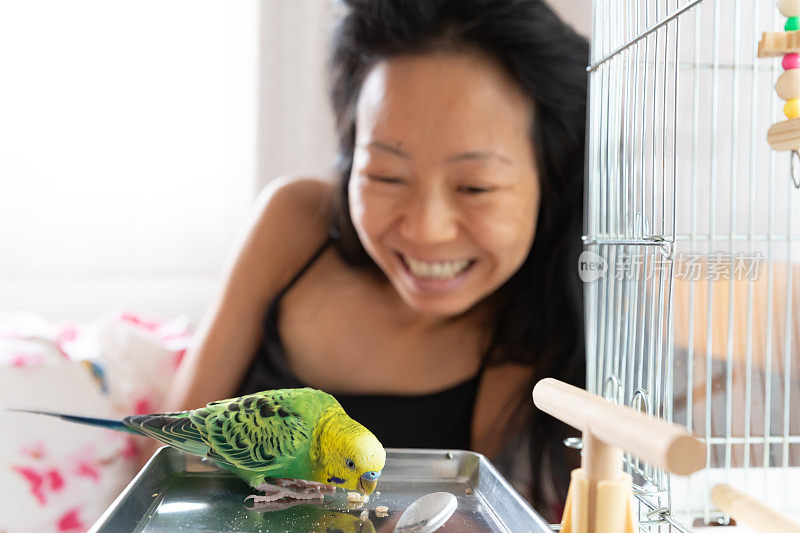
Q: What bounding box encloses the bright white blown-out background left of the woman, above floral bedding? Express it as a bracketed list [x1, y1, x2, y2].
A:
[0, 0, 258, 320]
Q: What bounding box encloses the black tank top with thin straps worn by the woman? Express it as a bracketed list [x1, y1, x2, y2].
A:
[237, 238, 486, 450]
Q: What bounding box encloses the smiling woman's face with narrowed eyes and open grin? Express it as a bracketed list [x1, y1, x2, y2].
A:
[348, 52, 539, 316]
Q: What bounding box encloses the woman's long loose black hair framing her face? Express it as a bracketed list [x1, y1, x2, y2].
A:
[329, 0, 589, 511]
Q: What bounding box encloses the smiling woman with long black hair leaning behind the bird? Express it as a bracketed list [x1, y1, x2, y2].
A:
[165, 0, 588, 516]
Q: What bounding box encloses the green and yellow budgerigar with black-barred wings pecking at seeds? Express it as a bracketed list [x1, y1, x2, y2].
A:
[10, 388, 386, 503]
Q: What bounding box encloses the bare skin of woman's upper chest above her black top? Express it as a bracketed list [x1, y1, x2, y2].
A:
[278, 260, 486, 394]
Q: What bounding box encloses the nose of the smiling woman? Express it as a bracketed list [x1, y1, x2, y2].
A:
[400, 190, 458, 244]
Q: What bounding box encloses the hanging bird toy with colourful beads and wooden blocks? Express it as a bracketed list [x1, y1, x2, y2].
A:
[758, 0, 800, 188]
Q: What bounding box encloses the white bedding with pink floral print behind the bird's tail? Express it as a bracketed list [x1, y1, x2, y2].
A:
[0, 312, 191, 533]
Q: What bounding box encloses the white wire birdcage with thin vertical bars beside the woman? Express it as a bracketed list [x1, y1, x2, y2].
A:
[580, 0, 800, 532]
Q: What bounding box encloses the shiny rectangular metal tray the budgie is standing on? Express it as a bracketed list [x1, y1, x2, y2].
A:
[90, 447, 551, 533]
